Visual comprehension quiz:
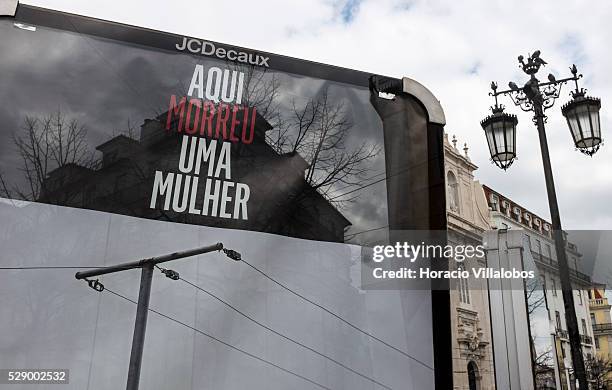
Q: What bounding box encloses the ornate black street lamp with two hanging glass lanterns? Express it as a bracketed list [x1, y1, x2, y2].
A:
[481, 50, 602, 389]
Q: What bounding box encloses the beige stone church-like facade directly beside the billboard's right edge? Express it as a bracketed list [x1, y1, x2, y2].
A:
[444, 135, 495, 390]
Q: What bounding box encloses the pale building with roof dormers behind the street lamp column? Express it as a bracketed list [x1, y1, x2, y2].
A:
[483, 185, 595, 390]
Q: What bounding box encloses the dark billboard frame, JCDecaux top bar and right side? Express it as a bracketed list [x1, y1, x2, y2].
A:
[0, 4, 453, 390]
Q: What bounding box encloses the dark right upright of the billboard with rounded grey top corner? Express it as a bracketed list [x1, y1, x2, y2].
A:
[369, 76, 454, 390]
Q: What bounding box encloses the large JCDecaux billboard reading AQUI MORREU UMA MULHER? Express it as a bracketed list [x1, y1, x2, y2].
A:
[0, 5, 452, 390]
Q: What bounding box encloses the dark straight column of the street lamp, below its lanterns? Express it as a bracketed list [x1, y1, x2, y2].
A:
[534, 99, 589, 390]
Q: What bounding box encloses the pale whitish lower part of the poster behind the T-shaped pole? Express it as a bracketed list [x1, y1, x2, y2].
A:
[0, 201, 433, 390]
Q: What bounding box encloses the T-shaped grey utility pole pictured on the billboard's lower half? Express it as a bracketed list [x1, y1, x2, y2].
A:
[74, 243, 241, 390]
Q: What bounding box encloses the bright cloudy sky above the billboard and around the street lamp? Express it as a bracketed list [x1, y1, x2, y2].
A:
[23, 0, 612, 229]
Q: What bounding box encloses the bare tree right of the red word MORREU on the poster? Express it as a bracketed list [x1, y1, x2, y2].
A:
[225, 65, 380, 204]
